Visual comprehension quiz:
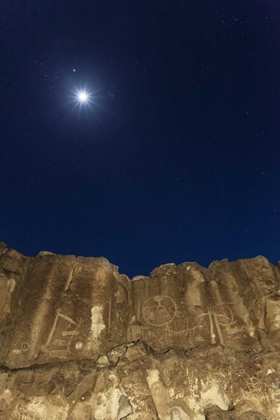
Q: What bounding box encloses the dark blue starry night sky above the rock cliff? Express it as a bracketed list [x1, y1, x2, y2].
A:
[0, 0, 280, 277]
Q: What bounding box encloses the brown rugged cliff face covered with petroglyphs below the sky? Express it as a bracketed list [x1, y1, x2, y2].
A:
[0, 243, 280, 420]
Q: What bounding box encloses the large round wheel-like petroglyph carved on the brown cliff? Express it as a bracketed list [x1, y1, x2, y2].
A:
[142, 295, 179, 327]
